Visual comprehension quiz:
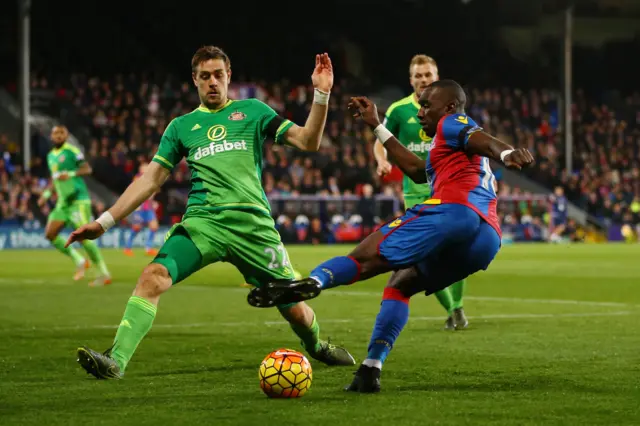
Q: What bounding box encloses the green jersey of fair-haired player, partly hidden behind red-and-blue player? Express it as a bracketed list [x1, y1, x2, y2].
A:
[383, 94, 433, 198]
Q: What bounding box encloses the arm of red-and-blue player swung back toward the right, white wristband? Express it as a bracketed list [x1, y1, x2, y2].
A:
[466, 131, 535, 170]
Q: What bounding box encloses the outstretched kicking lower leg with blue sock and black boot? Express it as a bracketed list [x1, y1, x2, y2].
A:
[247, 231, 393, 308]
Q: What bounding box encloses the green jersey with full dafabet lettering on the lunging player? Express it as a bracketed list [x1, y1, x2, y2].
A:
[153, 99, 293, 215]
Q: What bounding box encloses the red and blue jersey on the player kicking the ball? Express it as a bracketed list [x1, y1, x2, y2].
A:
[426, 114, 502, 235]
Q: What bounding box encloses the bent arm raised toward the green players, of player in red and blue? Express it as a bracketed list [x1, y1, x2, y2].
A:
[349, 96, 427, 183]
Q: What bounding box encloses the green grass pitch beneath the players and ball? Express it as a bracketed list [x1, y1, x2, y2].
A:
[0, 245, 640, 426]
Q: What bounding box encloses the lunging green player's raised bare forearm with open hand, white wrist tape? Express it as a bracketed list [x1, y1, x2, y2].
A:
[284, 53, 333, 151]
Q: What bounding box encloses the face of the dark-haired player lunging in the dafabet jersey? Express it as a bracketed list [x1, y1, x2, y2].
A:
[192, 59, 231, 109]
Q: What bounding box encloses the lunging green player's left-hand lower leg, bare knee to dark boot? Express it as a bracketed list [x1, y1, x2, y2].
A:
[78, 263, 172, 379]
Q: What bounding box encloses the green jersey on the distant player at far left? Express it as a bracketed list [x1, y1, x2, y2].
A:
[47, 142, 90, 205]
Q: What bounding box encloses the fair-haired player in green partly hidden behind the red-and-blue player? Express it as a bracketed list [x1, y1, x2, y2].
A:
[373, 55, 469, 330]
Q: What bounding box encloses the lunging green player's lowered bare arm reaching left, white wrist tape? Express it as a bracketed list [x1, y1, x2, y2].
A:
[66, 162, 170, 247]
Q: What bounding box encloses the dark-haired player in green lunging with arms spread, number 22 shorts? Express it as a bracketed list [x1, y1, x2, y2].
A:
[67, 46, 355, 379]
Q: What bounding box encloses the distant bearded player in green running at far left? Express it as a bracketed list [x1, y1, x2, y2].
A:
[38, 126, 111, 287]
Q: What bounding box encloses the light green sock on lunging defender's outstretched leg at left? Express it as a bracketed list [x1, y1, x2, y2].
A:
[111, 296, 157, 373]
